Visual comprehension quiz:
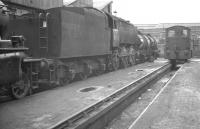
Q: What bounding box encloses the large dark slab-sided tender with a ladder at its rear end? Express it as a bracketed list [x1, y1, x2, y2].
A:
[2, 7, 122, 98]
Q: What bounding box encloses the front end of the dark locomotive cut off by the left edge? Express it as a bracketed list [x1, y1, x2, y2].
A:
[0, 1, 29, 98]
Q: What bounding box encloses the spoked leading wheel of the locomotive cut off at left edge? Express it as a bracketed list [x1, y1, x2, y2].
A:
[11, 73, 31, 99]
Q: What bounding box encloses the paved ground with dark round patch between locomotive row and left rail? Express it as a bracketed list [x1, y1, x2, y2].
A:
[0, 60, 167, 129]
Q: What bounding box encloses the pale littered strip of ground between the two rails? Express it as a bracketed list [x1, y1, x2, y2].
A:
[105, 72, 175, 129]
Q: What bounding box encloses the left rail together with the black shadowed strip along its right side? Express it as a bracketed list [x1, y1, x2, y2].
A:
[48, 64, 171, 129]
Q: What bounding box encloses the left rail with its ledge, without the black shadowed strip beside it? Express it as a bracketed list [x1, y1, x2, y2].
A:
[48, 64, 171, 129]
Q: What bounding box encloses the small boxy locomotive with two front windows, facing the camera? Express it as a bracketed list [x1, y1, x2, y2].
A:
[165, 26, 192, 68]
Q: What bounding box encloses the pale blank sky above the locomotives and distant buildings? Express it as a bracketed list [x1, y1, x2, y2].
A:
[108, 0, 200, 24]
